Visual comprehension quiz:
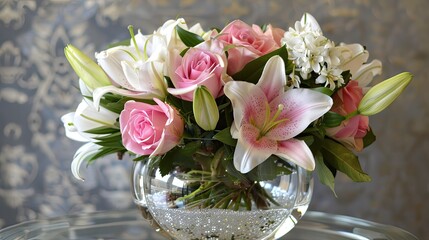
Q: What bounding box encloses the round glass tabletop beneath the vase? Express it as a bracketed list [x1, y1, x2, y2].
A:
[0, 210, 417, 240]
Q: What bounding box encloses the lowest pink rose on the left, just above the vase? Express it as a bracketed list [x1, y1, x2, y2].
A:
[119, 98, 184, 156]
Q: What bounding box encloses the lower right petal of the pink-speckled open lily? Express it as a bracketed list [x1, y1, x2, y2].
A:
[275, 138, 315, 171]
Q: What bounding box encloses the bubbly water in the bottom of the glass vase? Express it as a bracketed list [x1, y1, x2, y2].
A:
[150, 208, 289, 239]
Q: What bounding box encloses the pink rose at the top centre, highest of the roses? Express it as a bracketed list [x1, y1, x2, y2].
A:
[218, 20, 280, 75]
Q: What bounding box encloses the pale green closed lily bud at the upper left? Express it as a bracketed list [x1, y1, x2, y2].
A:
[64, 44, 112, 90]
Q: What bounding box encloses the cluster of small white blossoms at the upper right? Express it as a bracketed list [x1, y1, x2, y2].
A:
[282, 14, 366, 90]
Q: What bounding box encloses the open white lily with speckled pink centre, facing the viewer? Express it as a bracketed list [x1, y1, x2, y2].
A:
[224, 56, 332, 173]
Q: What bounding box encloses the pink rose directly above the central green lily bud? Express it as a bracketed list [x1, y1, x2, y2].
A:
[168, 40, 229, 101]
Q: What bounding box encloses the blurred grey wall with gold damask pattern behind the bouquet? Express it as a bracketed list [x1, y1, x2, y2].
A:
[0, 0, 429, 239]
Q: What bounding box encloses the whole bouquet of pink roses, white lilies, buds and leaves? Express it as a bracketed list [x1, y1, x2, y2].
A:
[62, 14, 412, 209]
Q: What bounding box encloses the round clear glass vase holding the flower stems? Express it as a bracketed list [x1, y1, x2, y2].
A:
[132, 158, 313, 239]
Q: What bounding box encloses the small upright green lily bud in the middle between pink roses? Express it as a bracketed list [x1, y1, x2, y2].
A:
[192, 86, 219, 131]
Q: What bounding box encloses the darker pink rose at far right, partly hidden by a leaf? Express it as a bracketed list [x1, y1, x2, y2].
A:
[326, 80, 369, 151]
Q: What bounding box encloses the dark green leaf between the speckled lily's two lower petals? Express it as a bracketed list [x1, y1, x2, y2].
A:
[246, 155, 292, 181]
